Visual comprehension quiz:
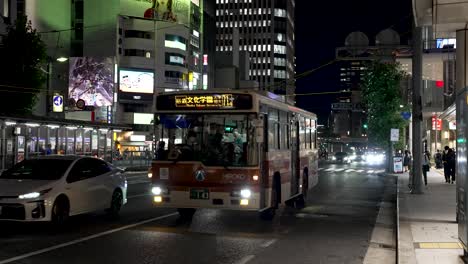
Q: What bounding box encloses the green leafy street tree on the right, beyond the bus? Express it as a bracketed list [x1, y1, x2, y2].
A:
[361, 61, 408, 165]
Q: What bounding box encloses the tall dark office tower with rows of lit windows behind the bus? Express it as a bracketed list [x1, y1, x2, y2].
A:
[216, 0, 295, 99]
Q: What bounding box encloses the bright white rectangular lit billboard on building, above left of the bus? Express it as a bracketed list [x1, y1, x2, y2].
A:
[119, 69, 154, 94]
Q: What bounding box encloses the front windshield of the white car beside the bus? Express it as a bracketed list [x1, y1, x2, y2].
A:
[0, 159, 73, 180]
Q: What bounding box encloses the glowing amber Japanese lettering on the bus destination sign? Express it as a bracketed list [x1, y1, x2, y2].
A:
[175, 94, 234, 108]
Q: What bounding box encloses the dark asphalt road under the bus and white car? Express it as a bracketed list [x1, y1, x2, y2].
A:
[0, 161, 389, 264]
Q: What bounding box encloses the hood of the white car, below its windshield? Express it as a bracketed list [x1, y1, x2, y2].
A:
[0, 179, 57, 196]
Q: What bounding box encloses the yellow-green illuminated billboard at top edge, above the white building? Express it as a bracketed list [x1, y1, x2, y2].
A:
[120, 0, 191, 25]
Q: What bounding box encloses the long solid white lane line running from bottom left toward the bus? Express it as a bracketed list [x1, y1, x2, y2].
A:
[0, 213, 178, 264]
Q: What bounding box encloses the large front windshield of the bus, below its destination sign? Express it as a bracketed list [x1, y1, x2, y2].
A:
[156, 114, 258, 167]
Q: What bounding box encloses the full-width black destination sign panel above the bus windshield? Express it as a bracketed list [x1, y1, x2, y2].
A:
[156, 93, 252, 110]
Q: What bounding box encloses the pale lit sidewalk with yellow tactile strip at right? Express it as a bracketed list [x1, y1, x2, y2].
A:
[398, 168, 464, 264]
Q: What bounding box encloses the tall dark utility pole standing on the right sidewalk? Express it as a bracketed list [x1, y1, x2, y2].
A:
[410, 27, 423, 194]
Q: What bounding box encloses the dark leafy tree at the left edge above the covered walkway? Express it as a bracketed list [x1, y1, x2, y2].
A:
[0, 17, 47, 114]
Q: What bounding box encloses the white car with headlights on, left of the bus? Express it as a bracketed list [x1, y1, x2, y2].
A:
[0, 156, 127, 223]
